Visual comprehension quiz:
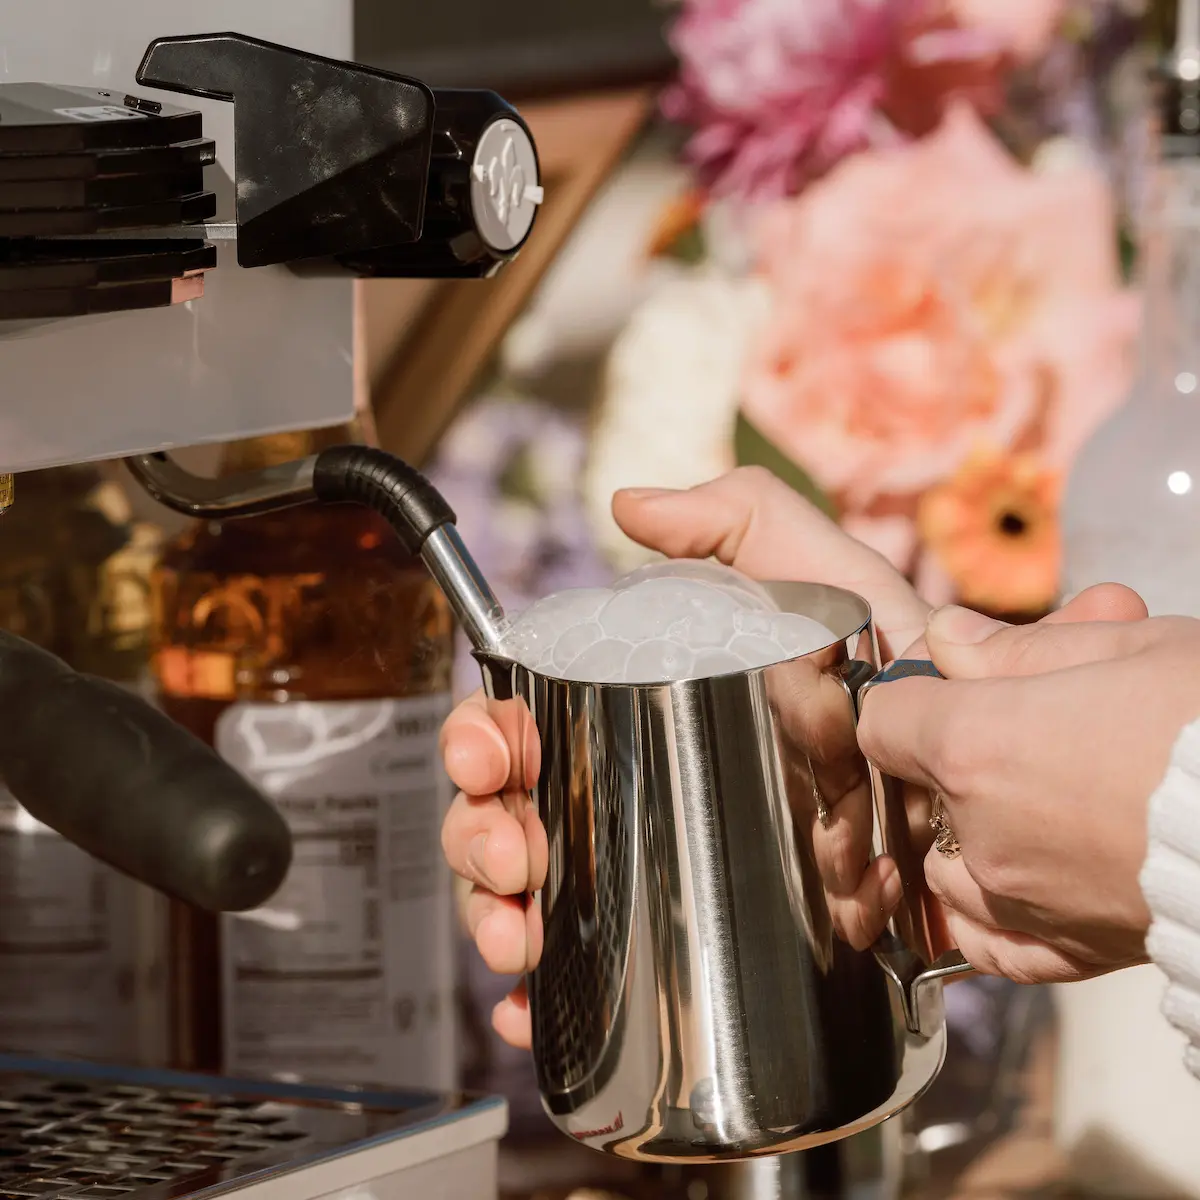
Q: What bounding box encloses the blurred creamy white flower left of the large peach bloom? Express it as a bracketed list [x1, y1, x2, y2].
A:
[583, 271, 768, 571]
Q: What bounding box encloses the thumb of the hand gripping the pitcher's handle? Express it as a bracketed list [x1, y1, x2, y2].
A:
[925, 606, 1146, 679]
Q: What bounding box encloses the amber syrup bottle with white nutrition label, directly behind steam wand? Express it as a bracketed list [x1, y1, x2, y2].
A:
[146, 421, 457, 1088]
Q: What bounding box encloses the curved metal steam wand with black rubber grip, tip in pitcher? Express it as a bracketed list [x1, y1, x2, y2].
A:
[125, 445, 508, 654]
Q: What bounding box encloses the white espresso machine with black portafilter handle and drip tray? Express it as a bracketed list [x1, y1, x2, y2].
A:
[0, 0, 542, 1200]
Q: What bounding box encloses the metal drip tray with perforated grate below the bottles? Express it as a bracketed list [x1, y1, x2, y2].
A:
[0, 1052, 505, 1200]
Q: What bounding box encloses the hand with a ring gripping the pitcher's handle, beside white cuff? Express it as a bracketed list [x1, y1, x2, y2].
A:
[859, 589, 1200, 983]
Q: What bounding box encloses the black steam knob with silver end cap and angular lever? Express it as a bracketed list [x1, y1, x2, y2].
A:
[137, 34, 542, 278]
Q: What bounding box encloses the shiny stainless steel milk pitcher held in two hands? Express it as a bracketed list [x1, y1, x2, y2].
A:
[476, 583, 966, 1162]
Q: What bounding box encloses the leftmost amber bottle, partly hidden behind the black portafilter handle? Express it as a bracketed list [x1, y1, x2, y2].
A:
[0, 467, 168, 1066]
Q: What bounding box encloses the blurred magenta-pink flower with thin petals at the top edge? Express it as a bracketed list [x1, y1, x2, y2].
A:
[662, 0, 1006, 199]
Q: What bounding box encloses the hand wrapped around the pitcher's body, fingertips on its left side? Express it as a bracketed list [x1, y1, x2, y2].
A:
[442, 468, 930, 1046]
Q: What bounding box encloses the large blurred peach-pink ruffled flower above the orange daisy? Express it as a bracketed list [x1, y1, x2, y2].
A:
[743, 107, 1138, 548]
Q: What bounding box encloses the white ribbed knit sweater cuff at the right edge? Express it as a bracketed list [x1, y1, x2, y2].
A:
[1141, 721, 1200, 1075]
